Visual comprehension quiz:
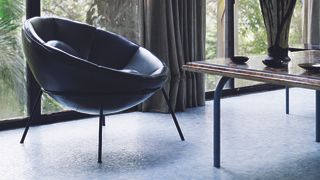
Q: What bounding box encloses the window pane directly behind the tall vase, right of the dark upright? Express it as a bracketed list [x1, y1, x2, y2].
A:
[235, 0, 302, 88]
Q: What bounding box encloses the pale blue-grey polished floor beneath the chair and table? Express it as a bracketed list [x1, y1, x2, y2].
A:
[0, 88, 320, 180]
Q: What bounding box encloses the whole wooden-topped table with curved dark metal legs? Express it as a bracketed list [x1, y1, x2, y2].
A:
[183, 51, 320, 167]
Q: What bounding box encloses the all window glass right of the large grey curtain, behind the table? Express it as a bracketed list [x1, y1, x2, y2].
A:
[206, 0, 303, 91]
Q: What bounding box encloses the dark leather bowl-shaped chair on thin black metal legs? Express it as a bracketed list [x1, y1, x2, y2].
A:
[20, 17, 184, 162]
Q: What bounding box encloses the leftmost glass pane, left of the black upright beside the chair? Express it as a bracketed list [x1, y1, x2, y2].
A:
[0, 0, 26, 121]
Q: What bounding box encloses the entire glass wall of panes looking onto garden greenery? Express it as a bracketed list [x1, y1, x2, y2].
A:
[0, 0, 302, 120]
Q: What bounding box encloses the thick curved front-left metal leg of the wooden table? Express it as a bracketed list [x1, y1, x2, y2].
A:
[213, 77, 231, 168]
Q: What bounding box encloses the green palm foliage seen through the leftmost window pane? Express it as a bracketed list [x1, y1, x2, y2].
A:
[0, 0, 25, 118]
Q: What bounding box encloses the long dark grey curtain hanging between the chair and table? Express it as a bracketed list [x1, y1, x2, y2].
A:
[140, 0, 205, 112]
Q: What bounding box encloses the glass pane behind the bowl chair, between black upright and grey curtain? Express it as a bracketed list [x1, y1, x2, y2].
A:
[41, 0, 142, 113]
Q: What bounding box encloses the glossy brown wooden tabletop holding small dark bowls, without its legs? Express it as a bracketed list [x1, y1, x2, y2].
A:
[183, 50, 320, 90]
